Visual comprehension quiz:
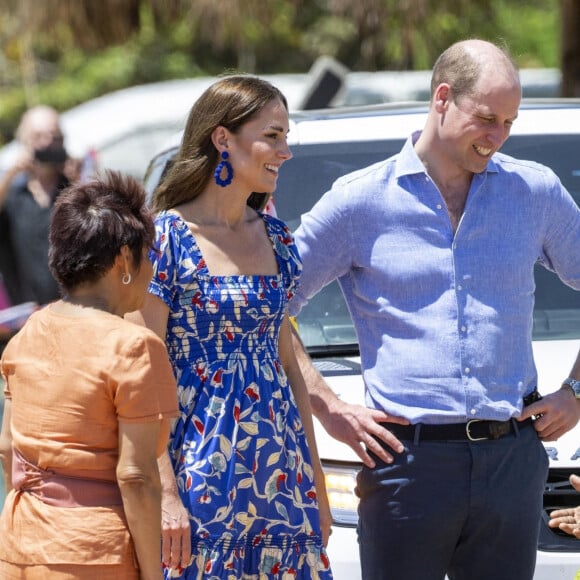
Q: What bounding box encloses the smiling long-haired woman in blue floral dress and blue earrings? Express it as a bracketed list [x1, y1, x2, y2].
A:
[129, 75, 332, 580]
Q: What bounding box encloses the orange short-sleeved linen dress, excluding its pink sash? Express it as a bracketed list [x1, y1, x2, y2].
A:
[0, 306, 177, 580]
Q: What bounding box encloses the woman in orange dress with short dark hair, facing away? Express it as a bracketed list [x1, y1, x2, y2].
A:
[0, 173, 177, 580]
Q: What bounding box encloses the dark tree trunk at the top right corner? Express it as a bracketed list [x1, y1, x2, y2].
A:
[560, 0, 580, 97]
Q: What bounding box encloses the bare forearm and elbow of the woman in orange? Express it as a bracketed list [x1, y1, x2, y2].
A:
[117, 421, 163, 580]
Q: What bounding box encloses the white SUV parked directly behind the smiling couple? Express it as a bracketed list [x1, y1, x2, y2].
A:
[145, 100, 580, 580]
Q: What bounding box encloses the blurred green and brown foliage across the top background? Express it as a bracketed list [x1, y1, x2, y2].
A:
[0, 0, 580, 143]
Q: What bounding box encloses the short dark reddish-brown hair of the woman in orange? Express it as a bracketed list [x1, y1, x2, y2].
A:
[48, 171, 155, 292]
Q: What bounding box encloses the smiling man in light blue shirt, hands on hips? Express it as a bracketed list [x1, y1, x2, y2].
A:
[290, 40, 580, 580]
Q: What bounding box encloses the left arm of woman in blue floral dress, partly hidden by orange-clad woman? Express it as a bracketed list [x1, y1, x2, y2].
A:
[125, 294, 191, 568]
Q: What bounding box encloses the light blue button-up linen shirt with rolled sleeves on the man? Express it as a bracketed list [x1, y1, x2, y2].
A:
[290, 134, 580, 424]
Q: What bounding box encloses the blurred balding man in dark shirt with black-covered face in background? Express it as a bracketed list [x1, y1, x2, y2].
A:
[0, 105, 79, 305]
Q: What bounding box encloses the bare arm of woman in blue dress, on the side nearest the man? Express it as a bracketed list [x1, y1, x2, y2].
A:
[279, 315, 332, 546]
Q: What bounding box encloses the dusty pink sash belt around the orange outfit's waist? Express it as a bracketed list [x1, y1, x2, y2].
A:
[12, 448, 123, 507]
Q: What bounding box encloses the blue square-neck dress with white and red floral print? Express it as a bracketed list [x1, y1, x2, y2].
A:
[149, 212, 332, 580]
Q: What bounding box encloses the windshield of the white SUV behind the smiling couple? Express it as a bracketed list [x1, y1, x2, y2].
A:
[275, 135, 580, 354]
